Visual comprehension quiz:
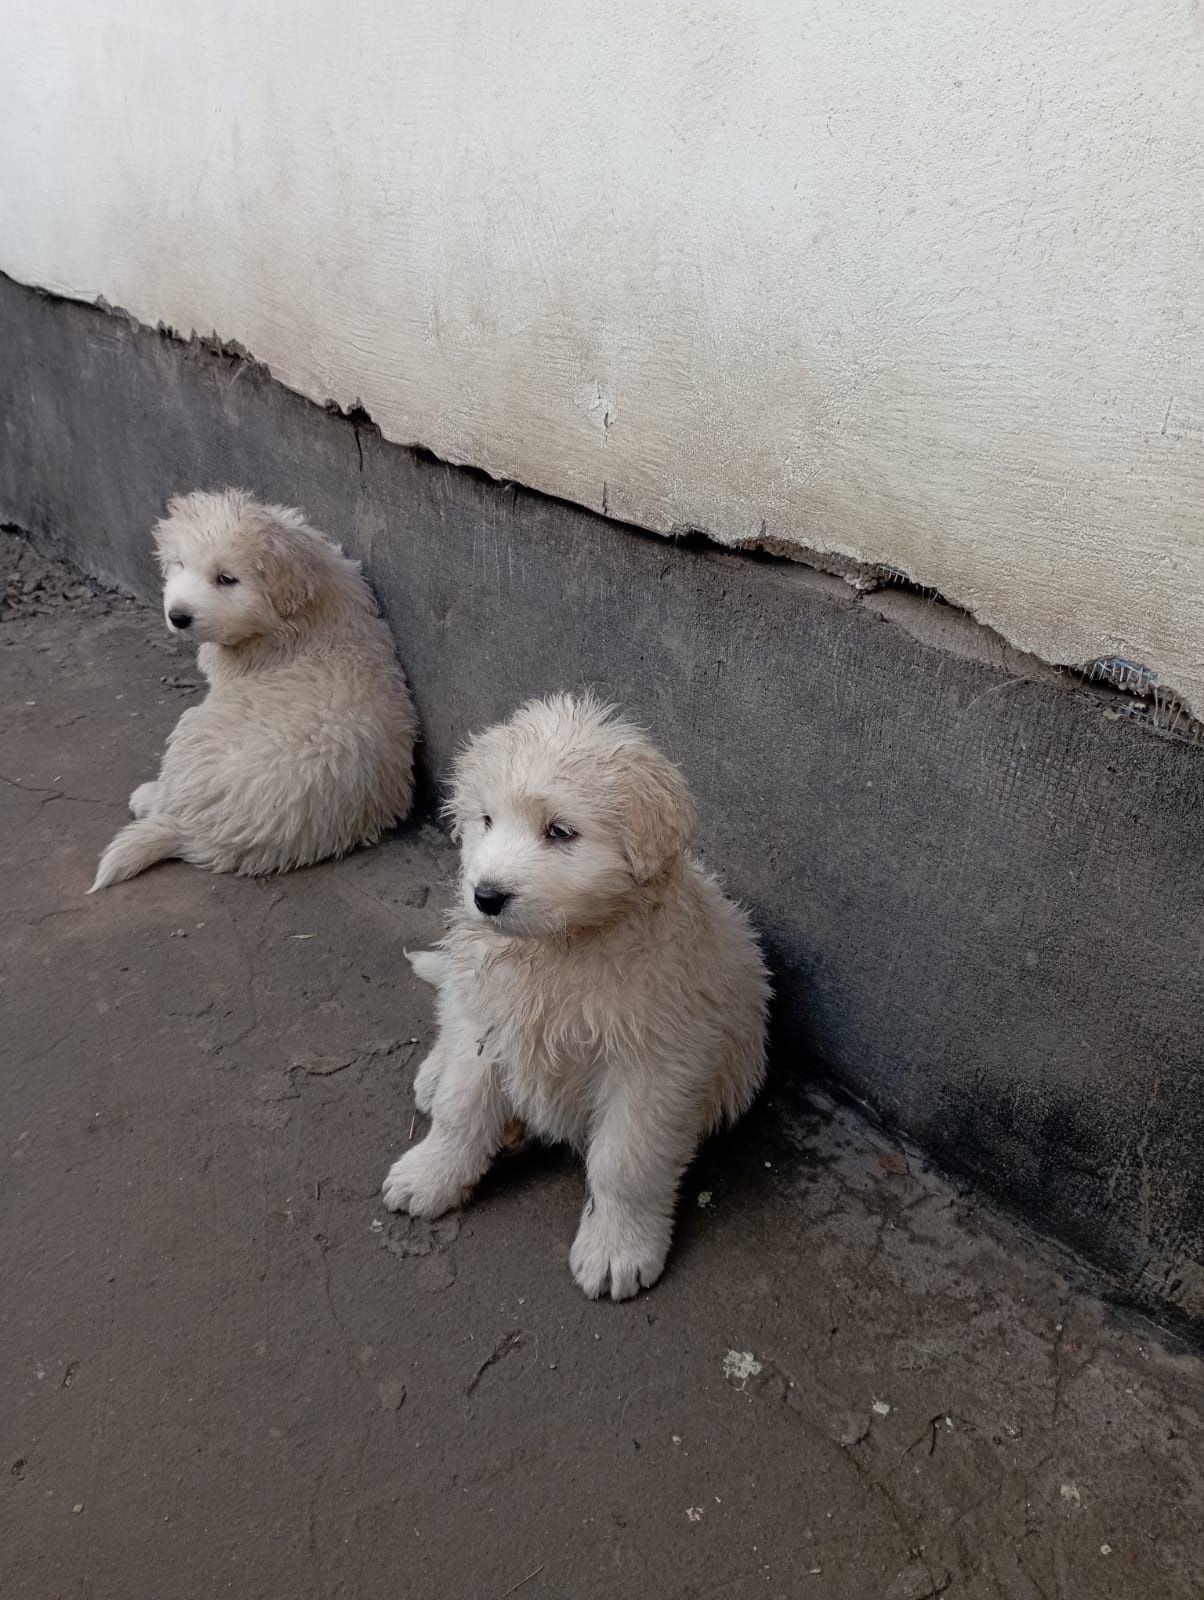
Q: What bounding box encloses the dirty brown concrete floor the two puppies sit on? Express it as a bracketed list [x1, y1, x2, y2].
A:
[0, 541, 1204, 1600]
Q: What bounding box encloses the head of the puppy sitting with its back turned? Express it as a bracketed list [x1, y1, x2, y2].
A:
[154, 490, 335, 646]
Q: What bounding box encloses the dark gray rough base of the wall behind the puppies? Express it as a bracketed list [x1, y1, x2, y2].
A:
[0, 280, 1204, 1326]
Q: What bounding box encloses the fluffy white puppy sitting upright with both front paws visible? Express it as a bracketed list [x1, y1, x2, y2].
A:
[384, 694, 769, 1299]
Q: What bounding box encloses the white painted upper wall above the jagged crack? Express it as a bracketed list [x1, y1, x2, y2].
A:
[0, 0, 1204, 712]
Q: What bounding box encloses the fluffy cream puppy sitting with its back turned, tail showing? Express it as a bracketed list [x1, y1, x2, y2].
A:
[90, 490, 418, 893]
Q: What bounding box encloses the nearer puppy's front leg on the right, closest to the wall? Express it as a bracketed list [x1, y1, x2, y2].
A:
[568, 1062, 698, 1299]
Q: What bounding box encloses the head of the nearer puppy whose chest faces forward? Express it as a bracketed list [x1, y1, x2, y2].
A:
[448, 694, 695, 938]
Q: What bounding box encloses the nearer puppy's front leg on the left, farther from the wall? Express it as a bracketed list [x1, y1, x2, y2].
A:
[383, 1019, 509, 1216]
